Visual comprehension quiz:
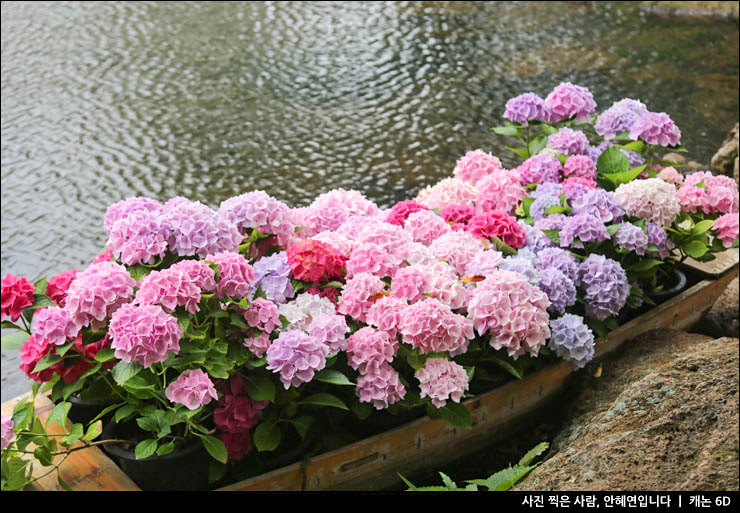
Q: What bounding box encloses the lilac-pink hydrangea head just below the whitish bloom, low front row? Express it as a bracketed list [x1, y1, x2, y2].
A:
[266, 330, 329, 390]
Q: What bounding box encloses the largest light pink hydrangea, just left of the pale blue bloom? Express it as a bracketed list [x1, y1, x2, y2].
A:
[468, 270, 550, 359]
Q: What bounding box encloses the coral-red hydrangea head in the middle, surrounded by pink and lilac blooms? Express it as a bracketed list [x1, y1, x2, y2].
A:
[287, 239, 346, 283]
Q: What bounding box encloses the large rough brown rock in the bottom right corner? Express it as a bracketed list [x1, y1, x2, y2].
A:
[515, 330, 740, 491]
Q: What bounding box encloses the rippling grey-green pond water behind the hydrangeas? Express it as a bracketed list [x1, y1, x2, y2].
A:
[0, 2, 738, 401]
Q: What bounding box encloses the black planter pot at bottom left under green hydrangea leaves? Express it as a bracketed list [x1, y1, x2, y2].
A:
[103, 422, 211, 491]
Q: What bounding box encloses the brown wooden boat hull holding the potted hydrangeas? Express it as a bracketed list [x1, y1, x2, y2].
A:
[2, 249, 738, 491]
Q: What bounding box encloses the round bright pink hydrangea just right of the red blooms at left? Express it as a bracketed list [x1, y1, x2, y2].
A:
[108, 303, 182, 367]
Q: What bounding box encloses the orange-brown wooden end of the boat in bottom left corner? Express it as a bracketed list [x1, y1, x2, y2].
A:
[2, 393, 140, 491]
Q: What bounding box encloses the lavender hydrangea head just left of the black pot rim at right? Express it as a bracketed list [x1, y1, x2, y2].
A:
[578, 253, 630, 321]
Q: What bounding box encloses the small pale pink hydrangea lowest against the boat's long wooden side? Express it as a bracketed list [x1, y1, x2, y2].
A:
[414, 358, 469, 408]
